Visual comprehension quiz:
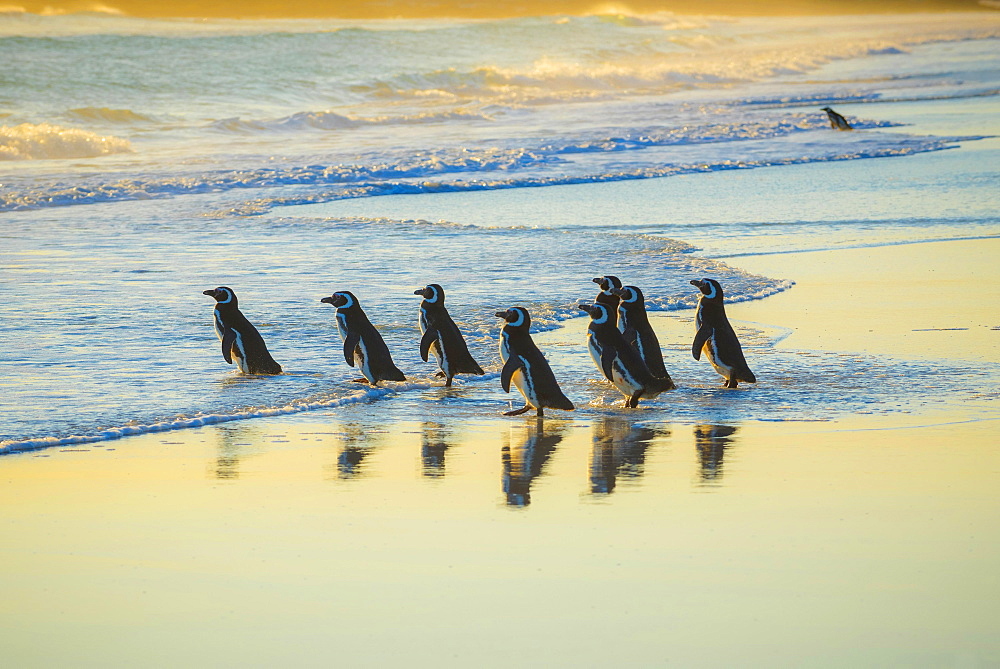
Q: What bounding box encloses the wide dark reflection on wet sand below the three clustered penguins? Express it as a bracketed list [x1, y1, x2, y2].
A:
[590, 416, 669, 495]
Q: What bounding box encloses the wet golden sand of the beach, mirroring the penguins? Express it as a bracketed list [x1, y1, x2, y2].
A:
[0, 240, 1000, 667]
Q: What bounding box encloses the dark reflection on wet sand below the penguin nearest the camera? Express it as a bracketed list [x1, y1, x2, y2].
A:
[501, 418, 564, 507]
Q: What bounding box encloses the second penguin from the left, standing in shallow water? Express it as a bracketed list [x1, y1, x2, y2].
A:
[320, 290, 406, 386]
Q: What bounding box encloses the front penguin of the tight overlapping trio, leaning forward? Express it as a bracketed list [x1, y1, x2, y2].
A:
[579, 302, 674, 408]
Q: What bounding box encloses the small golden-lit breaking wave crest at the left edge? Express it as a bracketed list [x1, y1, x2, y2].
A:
[0, 123, 132, 160]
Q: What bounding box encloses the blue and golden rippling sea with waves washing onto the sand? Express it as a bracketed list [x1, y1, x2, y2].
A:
[0, 14, 1000, 451]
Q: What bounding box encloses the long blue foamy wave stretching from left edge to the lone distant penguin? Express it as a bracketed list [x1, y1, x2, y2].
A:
[0, 115, 952, 210]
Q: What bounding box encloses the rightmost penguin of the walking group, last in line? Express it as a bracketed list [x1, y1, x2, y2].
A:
[691, 279, 757, 388]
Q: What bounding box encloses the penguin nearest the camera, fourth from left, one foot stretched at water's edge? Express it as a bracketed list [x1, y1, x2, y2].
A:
[496, 307, 575, 416]
